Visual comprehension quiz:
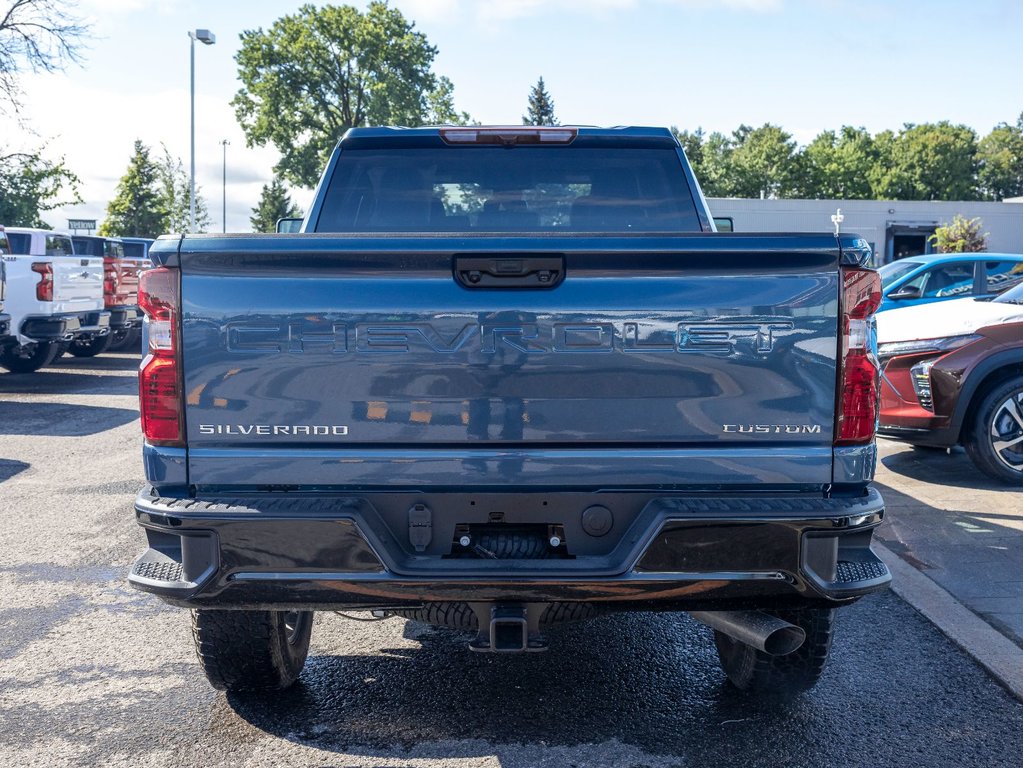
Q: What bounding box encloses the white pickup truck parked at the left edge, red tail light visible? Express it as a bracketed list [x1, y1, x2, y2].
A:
[0, 227, 110, 373]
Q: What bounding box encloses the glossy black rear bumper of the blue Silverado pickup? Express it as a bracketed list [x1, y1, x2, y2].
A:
[129, 488, 891, 609]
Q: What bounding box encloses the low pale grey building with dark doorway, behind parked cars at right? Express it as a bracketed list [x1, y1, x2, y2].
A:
[707, 197, 1023, 265]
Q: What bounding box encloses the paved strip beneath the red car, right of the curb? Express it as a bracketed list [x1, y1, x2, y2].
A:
[877, 440, 1023, 648]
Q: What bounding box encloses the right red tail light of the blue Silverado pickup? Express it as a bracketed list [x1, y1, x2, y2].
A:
[835, 267, 881, 445]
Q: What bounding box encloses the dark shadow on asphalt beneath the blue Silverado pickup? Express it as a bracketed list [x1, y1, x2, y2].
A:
[217, 593, 1023, 768]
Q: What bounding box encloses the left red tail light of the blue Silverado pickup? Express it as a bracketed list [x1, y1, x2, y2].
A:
[138, 267, 184, 447]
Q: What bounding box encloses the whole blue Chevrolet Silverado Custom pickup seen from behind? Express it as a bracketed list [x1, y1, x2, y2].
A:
[129, 127, 890, 694]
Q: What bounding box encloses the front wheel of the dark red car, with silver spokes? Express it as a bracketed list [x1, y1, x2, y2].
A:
[965, 376, 1023, 485]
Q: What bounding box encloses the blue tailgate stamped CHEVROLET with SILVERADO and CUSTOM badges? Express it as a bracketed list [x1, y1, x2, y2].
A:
[177, 235, 839, 489]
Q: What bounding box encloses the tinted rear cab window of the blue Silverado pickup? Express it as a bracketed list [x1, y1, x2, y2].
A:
[316, 145, 701, 233]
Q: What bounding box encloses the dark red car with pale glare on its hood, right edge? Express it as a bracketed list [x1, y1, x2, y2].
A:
[877, 284, 1023, 484]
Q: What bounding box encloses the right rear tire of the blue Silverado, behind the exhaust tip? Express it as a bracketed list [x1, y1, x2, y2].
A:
[714, 608, 835, 697]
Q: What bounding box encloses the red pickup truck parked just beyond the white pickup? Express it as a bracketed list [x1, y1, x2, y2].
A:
[68, 235, 149, 357]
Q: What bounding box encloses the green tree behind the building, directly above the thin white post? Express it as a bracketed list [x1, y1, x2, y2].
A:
[798, 126, 878, 199]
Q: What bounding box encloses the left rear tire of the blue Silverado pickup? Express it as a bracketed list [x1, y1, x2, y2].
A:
[192, 611, 313, 691]
